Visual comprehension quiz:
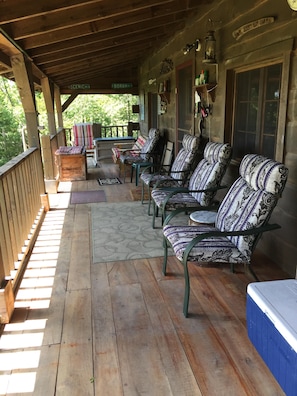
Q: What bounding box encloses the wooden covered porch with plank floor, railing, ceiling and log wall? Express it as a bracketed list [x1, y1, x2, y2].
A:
[0, 0, 297, 396]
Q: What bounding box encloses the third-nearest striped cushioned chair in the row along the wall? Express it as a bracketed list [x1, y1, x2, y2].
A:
[140, 134, 200, 214]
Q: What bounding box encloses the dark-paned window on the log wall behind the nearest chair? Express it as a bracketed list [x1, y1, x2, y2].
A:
[233, 63, 282, 160]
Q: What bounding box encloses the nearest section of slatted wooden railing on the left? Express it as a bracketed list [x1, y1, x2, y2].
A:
[0, 148, 45, 290]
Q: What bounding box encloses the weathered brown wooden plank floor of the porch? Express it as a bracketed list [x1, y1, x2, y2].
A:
[0, 165, 288, 396]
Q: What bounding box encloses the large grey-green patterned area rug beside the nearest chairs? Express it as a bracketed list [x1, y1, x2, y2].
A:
[92, 202, 188, 263]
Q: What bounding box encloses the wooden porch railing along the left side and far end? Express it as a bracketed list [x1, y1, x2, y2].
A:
[0, 123, 137, 300]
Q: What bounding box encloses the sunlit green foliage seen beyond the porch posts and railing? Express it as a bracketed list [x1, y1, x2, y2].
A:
[0, 77, 138, 166]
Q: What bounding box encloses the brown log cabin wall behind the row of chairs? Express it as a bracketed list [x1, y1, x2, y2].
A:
[139, 0, 297, 277]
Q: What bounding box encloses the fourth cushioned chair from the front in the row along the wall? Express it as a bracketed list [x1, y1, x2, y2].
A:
[120, 128, 160, 182]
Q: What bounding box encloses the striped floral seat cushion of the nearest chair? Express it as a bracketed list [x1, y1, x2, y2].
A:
[163, 225, 250, 263]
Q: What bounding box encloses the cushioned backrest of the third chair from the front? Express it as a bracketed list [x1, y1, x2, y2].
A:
[170, 134, 200, 184]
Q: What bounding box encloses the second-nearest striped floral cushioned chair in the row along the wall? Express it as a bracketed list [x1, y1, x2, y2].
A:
[151, 142, 232, 228]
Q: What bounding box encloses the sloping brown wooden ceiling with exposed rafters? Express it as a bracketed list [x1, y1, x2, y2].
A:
[0, 0, 212, 93]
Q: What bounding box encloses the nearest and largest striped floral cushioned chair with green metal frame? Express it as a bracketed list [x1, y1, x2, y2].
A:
[163, 154, 288, 316]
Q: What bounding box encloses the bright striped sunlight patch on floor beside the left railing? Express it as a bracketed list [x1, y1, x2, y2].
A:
[0, 210, 66, 395]
